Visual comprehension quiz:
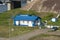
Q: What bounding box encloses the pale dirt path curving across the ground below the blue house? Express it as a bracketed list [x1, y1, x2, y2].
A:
[0, 29, 60, 40]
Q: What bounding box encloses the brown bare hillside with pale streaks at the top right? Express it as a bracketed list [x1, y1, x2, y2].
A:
[21, 0, 60, 13]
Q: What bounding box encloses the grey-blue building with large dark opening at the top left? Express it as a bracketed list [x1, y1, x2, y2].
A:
[0, 0, 27, 12]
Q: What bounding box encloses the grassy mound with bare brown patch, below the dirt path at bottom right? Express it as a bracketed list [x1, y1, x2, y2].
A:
[29, 34, 60, 40]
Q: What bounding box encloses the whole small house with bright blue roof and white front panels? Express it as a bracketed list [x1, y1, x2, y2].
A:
[14, 15, 41, 27]
